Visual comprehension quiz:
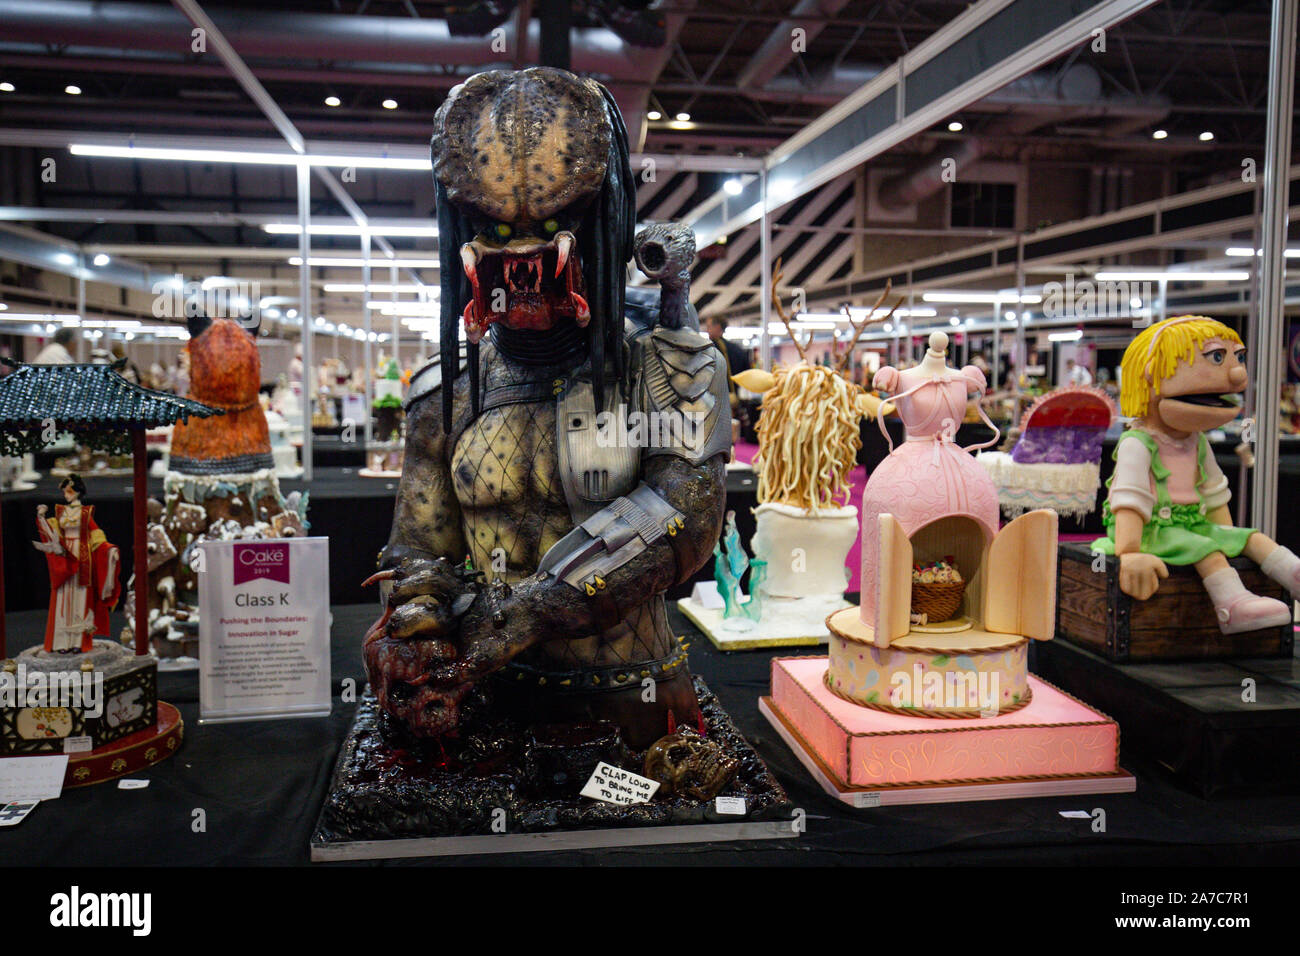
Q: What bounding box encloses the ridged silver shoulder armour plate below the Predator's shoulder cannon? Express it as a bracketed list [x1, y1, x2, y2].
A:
[642, 326, 731, 464]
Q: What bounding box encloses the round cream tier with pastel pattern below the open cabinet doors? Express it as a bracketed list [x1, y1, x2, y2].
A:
[826, 607, 1032, 717]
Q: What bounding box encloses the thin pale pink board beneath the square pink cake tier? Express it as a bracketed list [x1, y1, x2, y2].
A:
[758, 697, 1138, 809]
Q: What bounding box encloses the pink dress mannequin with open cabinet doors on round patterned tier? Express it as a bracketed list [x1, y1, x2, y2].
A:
[826, 332, 1057, 717]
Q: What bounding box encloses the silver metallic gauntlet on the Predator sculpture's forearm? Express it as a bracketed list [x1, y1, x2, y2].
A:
[537, 485, 685, 597]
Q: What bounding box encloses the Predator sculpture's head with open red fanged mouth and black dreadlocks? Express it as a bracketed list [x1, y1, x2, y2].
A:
[432, 66, 636, 423]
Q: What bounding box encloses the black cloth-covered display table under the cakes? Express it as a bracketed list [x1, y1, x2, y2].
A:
[4, 605, 1300, 866]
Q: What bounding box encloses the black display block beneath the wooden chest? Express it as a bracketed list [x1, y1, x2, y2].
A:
[1034, 640, 1300, 799]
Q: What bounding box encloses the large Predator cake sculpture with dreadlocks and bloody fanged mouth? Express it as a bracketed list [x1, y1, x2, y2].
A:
[319, 68, 785, 839]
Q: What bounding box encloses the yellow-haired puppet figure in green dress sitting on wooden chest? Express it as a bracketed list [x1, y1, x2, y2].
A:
[1092, 315, 1300, 633]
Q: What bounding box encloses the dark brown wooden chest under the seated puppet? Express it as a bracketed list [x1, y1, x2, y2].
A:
[1057, 542, 1295, 662]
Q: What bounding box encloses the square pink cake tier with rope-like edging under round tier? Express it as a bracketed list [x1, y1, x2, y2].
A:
[771, 657, 1119, 790]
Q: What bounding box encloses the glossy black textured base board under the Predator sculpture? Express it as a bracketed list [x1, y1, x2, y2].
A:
[311, 676, 797, 861]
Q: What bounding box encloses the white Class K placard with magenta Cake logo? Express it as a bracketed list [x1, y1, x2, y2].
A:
[199, 537, 330, 723]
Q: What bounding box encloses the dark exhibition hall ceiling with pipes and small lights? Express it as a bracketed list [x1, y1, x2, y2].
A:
[0, 0, 1289, 325]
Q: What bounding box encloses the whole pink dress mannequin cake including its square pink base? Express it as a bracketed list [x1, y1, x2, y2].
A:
[761, 332, 1132, 805]
